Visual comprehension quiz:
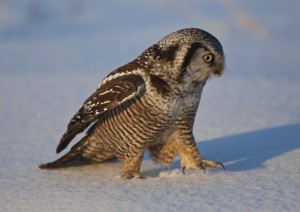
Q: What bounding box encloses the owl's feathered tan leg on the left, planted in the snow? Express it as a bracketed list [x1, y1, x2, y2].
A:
[121, 153, 144, 179]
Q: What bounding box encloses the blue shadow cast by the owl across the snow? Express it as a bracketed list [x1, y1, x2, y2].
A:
[197, 124, 300, 171]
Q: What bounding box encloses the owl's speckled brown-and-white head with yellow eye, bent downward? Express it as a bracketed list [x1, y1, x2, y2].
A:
[138, 28, 225, 82]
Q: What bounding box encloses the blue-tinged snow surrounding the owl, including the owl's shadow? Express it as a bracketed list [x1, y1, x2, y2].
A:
[0, 0, 300, 211]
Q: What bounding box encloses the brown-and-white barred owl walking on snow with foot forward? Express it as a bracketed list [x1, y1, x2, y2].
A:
[39, 28, 225, 179]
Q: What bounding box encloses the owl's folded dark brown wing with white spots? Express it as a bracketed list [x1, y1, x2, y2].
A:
[56, 74, 145, 153]
